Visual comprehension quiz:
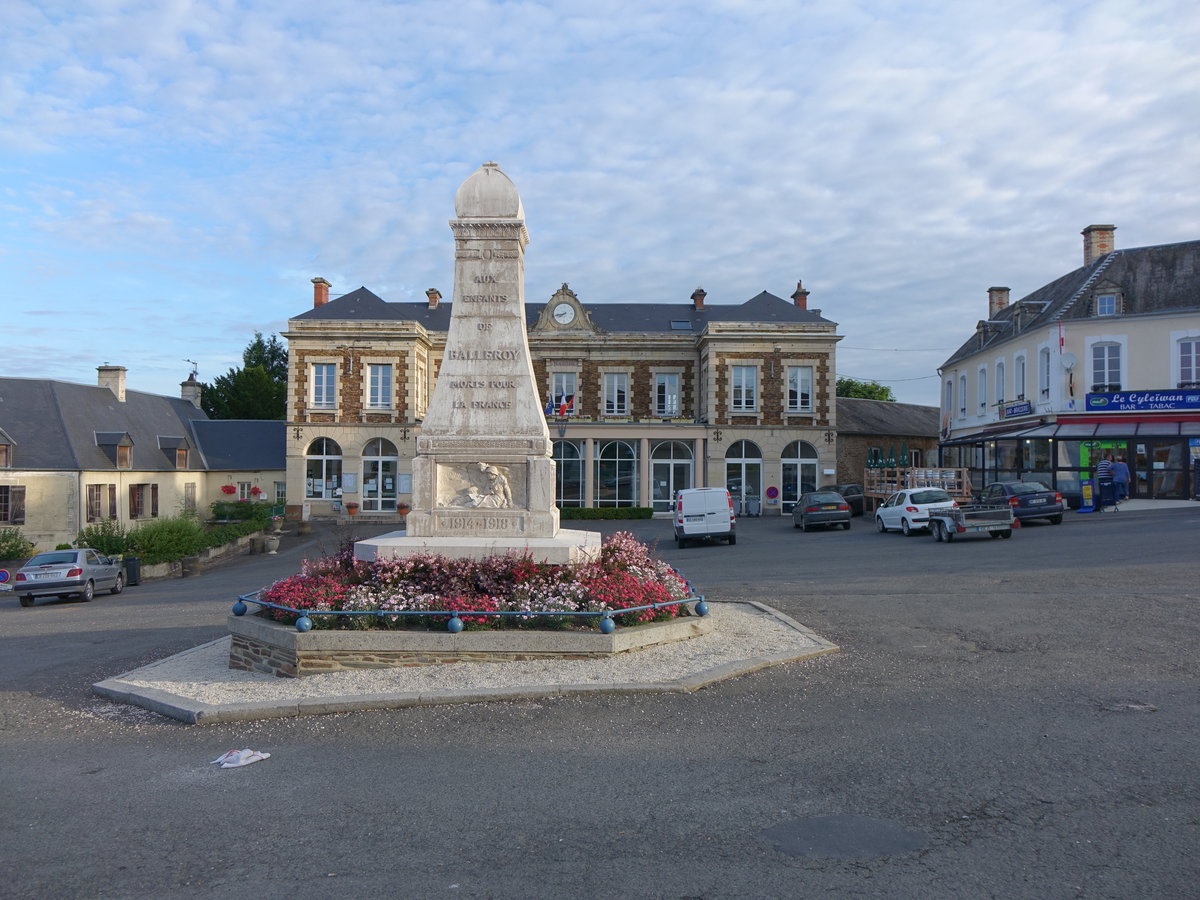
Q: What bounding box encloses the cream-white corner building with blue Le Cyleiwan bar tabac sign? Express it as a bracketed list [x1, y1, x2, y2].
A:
[938, 224, 1200, 503]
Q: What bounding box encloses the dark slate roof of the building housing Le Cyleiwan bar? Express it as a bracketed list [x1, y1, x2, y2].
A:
[942, 241, 1200, 368]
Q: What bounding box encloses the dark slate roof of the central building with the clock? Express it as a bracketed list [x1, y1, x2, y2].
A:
[293, 288, 834, 335]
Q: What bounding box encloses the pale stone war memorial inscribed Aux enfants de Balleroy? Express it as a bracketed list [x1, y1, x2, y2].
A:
[355, 162, 600, 564]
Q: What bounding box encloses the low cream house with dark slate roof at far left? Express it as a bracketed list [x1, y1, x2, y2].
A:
[0, 365, 286, 550]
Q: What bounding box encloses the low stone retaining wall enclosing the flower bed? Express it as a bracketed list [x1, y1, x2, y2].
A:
[228, 614, 715, 678]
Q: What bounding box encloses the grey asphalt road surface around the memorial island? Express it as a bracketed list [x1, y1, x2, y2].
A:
[0, 509, 1200, 899]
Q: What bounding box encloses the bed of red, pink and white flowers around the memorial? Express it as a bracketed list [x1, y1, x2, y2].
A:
[259, 532, 691, 630]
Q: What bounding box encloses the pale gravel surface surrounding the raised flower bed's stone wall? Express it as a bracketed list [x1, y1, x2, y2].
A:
[114, 602, 832, 704]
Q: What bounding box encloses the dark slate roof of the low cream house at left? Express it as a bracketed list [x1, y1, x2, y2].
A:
[0, 377, 287, 472]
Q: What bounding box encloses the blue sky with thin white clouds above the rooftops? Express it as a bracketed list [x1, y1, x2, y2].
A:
[0, 0, 1200, 404]
